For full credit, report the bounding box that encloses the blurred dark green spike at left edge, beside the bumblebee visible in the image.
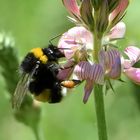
[0,35,19,95]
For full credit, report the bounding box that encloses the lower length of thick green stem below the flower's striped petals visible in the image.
[94,85,107,140]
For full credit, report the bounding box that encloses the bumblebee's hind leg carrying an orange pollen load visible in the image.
[61,79,82,88]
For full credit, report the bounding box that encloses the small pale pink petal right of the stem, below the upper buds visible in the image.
[109,22,126,40]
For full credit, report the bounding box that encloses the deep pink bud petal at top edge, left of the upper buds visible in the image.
[62,0,80,16]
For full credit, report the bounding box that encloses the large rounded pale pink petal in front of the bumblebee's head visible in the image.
[58,27,93,59]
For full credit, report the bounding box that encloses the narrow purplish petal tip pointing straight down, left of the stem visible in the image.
[83,80,94,103]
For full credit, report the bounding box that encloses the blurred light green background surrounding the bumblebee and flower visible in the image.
[0,0,140,140]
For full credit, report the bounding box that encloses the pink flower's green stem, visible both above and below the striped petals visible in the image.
[93,27,107,140]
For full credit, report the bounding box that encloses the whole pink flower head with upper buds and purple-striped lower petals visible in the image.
[58,0,140,103]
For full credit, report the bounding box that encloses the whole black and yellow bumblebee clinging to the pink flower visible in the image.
[12,44,80,108]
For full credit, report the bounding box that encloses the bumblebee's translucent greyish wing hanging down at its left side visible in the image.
[12,73,30,109]
